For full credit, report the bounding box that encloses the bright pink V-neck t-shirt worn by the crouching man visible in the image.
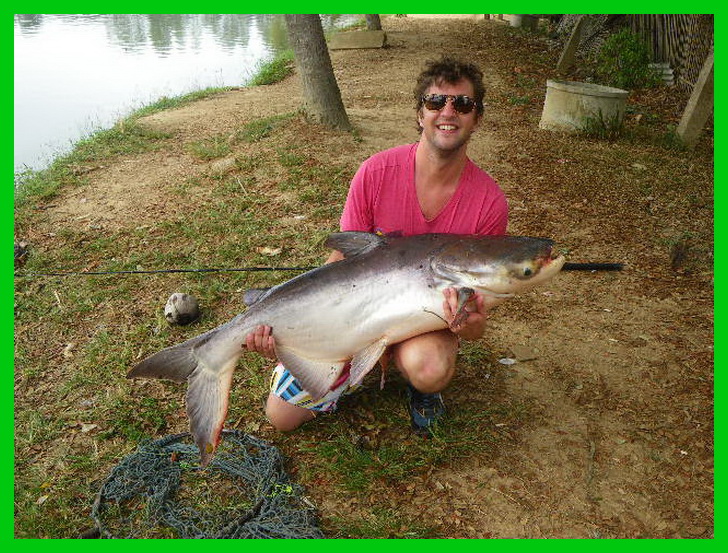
[341,142,508,236]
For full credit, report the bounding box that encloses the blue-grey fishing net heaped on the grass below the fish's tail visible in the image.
[91,430,324,538]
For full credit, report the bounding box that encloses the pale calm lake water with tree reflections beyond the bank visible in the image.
[14,14,362,171]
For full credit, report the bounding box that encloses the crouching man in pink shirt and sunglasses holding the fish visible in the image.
[246,58,508,436]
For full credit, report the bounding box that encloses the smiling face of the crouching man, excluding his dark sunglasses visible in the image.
[418,79,480,153]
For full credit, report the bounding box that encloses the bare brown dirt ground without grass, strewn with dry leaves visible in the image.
[19,18,713,538]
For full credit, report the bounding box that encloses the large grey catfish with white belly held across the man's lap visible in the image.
[128,232,564,466]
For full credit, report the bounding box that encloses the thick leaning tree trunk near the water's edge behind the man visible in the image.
[286,14,351,130]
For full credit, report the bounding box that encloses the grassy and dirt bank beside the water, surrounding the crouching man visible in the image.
[15,18,713,538]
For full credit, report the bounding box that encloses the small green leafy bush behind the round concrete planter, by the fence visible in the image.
[596,29,661,89]
